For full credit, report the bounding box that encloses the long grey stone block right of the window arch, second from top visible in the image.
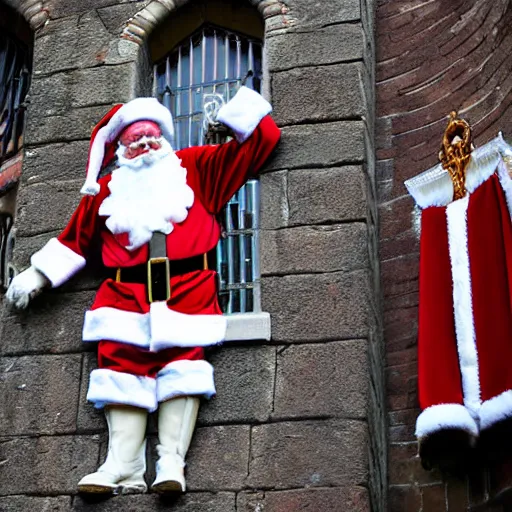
[265,23,364,71]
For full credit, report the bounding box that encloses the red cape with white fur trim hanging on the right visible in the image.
[406,136,512,450]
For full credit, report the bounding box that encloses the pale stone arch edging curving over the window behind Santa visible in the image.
[121,0,293,45]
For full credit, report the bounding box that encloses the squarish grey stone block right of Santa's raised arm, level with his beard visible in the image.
[288,165,366,225]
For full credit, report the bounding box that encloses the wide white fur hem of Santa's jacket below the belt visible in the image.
[83,302,226,352]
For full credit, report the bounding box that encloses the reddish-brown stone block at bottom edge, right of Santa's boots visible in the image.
[237,486,371,512]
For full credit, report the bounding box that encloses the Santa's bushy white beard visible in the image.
[99,140,194,251]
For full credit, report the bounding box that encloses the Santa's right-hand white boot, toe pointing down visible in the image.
[151,396,199,493]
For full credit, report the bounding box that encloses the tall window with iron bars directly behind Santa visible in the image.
[154,26,262,313]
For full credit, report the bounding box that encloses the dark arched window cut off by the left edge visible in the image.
[0,4,32,287]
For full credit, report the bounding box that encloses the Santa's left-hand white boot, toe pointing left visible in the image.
[78,406,148,494]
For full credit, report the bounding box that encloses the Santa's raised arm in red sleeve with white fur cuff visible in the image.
[186,87,280,214]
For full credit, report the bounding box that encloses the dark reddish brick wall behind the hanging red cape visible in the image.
[376,0,512,512]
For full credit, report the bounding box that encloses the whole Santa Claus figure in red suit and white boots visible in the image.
[7,87,279,493]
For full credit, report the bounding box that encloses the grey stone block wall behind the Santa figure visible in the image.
[0,0,386,512]
